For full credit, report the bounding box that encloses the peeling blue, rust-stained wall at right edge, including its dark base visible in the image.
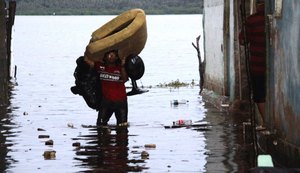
[260,0,300,164]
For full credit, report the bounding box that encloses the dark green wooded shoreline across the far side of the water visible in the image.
[12,0,203,15]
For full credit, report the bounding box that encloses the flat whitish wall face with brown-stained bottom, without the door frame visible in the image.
[203,0,225,95]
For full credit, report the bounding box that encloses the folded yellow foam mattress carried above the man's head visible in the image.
[85,9,147,61]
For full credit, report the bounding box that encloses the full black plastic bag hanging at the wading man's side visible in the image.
[71,56,102,110]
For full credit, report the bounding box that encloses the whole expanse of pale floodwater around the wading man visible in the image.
[0,15,253,173]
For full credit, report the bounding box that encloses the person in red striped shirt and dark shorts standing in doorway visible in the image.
[240,0,266,129]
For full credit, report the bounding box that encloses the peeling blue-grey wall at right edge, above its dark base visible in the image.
[267,0,300,146]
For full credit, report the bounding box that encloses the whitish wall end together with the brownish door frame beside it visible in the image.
[203,0,244,101]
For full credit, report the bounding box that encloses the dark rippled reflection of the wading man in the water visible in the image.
[74,127,146,173]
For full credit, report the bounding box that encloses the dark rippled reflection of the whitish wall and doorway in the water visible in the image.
[204,103,254,173]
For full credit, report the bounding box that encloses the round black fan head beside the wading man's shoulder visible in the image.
[125,55,145,80]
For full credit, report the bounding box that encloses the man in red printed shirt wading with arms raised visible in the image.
[84,50,128,126]
